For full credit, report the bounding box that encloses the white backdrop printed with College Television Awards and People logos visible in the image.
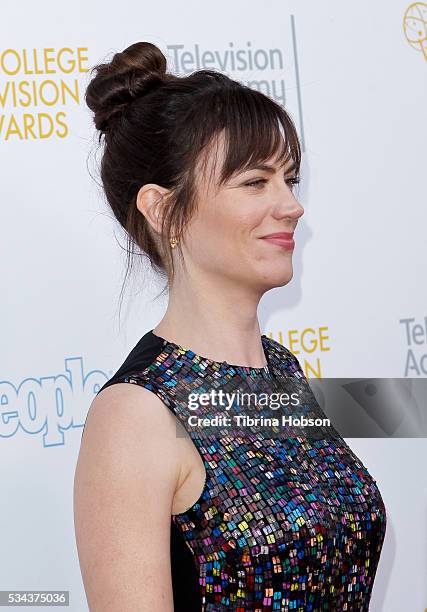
[0,0,427,612]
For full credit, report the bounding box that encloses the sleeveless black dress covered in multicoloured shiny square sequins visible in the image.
[93,330,386,612]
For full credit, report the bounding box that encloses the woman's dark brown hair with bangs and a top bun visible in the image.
[85,42,301,310]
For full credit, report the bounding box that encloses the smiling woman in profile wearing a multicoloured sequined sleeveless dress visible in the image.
[75,42,386,612]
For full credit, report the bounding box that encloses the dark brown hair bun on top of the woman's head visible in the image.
[85,42,166,132]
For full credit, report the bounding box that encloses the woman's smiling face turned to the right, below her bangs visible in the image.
[182,133,304,293]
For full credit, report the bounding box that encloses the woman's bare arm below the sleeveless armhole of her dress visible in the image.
[74,383,180,612]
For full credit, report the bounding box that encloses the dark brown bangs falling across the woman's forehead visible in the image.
[196,85,301,187]
